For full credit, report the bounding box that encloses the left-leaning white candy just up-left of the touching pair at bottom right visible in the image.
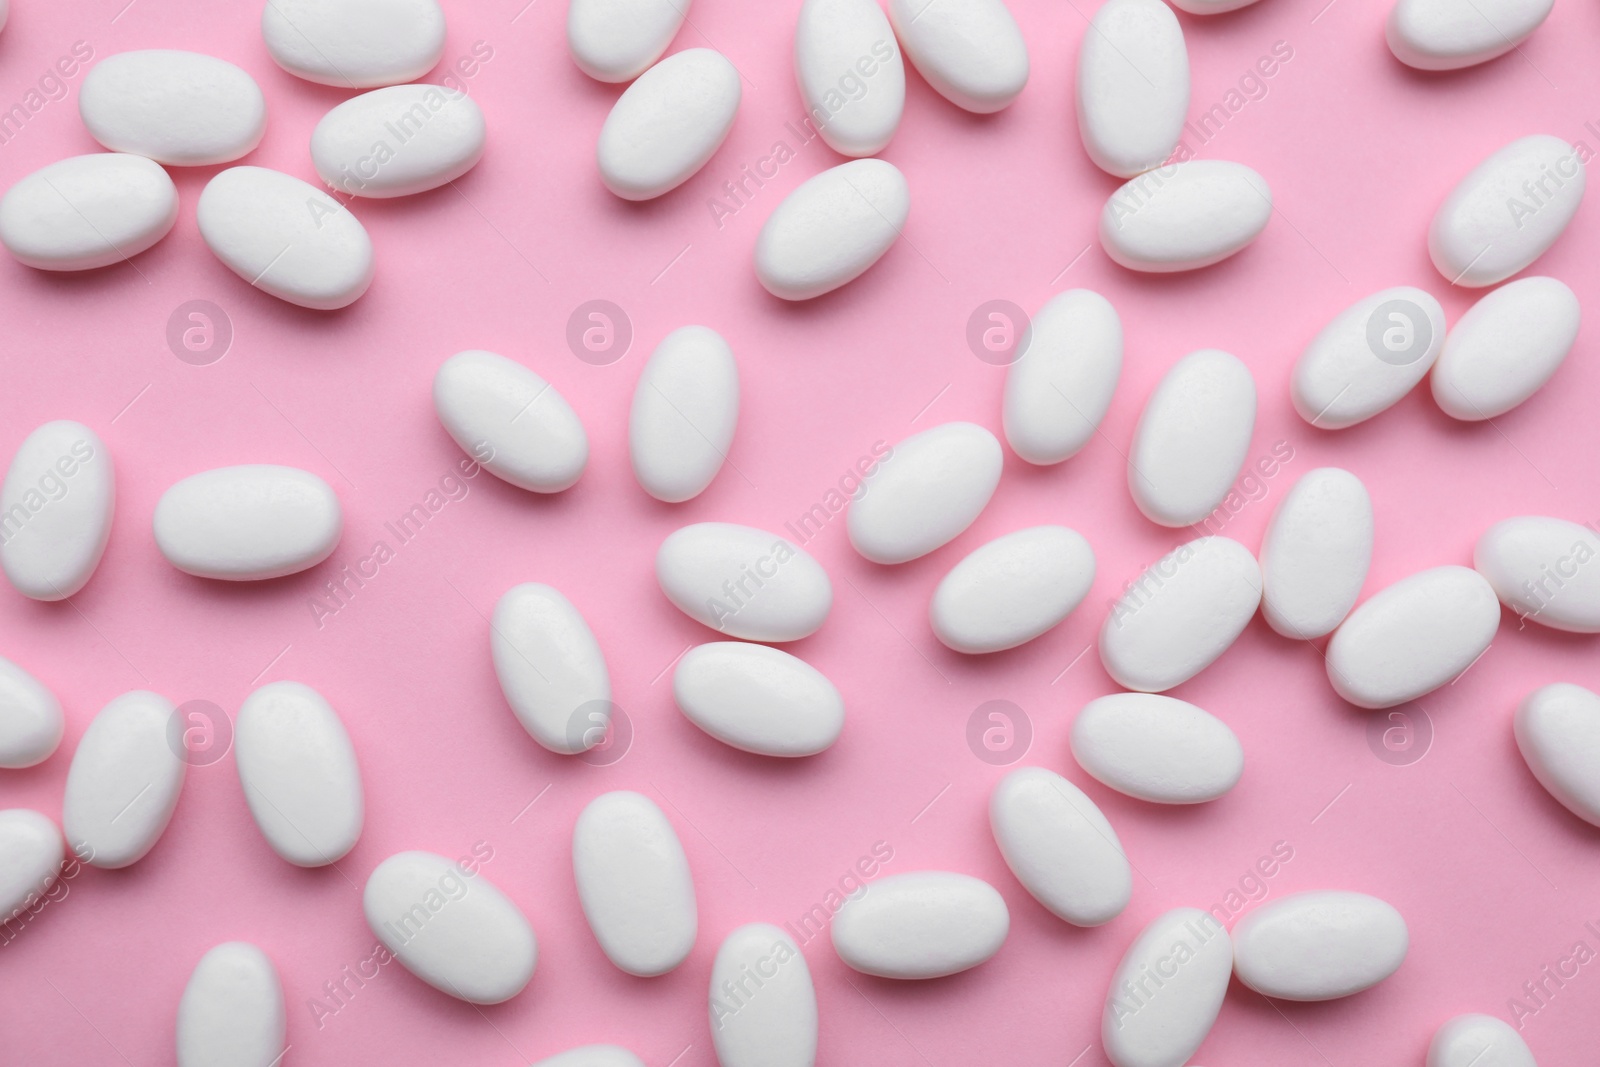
[989,766,1133,926]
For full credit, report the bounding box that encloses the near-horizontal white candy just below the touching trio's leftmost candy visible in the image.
[1072,693,1245,805]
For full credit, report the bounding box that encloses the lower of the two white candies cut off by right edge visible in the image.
[1515,681,1600,825]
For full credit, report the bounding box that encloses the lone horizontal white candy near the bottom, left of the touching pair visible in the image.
[829,870,1011,979]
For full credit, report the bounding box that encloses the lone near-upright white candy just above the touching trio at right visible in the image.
[1128,349,1256,526]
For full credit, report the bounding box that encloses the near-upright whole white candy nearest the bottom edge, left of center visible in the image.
[573,790,699,977]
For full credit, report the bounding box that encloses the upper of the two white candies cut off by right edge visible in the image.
[1472,515,1600,633]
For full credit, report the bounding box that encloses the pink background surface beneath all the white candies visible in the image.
[0,0,1600,1067]
